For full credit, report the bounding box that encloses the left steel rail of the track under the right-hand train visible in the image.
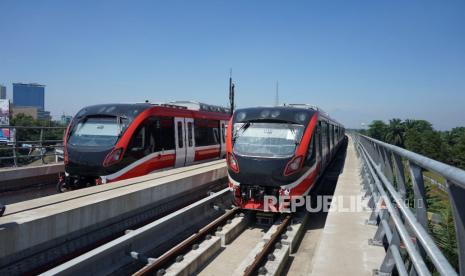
[133,207,240,276]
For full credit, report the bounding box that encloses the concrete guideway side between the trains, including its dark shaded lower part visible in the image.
[0,160,226,274]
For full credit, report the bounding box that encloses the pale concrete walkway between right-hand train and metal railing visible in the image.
[312,138,385,276]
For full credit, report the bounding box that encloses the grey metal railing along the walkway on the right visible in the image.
[352,133,465,275]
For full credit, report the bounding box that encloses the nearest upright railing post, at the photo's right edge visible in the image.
[446,180,465,276]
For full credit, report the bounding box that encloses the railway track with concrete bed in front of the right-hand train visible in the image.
[132,208,307,276]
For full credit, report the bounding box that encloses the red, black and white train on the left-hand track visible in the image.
[57,101,230,191]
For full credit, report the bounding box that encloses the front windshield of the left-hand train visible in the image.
[68,116,128,147]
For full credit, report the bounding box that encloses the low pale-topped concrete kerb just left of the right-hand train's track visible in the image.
[41,188,230,276]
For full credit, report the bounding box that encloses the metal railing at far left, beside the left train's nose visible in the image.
[0,126,66,167]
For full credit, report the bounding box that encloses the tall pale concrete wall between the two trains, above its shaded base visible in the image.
[0,160,227,267]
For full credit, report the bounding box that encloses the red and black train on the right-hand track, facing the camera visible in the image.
[226,104,345,212]
